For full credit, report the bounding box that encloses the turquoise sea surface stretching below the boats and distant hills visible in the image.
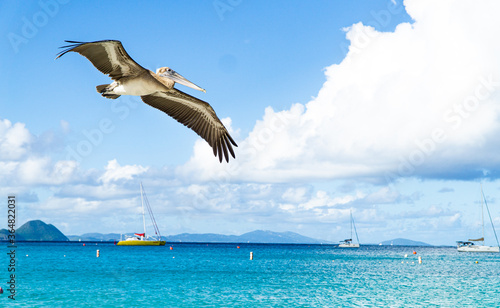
[0,243,500,307]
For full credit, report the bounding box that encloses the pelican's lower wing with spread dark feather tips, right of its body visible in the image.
[141,89,237,162]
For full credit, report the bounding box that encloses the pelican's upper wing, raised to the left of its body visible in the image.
[56,40,145,80]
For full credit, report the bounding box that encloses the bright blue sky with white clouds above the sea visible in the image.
[0,0,500,245]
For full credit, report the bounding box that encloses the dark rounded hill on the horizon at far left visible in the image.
[16,220,69,241]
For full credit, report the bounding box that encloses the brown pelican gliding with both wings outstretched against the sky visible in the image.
[56,40,237,162]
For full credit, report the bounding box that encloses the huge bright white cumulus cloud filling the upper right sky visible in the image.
[182,0,500,182]
